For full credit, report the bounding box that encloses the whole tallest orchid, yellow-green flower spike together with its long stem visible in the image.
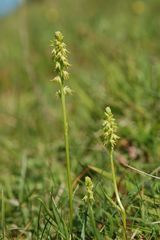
[51,31,73,229]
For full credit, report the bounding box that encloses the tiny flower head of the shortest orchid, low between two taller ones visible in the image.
[83,176,94,204]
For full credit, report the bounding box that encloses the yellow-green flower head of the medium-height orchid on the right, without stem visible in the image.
[103,107,119,149]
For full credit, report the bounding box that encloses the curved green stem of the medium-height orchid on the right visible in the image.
[110,148,127,240]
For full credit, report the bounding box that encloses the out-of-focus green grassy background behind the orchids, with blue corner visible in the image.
[0,0,160,190]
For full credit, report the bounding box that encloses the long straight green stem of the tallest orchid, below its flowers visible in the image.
[60,82,73,231]
